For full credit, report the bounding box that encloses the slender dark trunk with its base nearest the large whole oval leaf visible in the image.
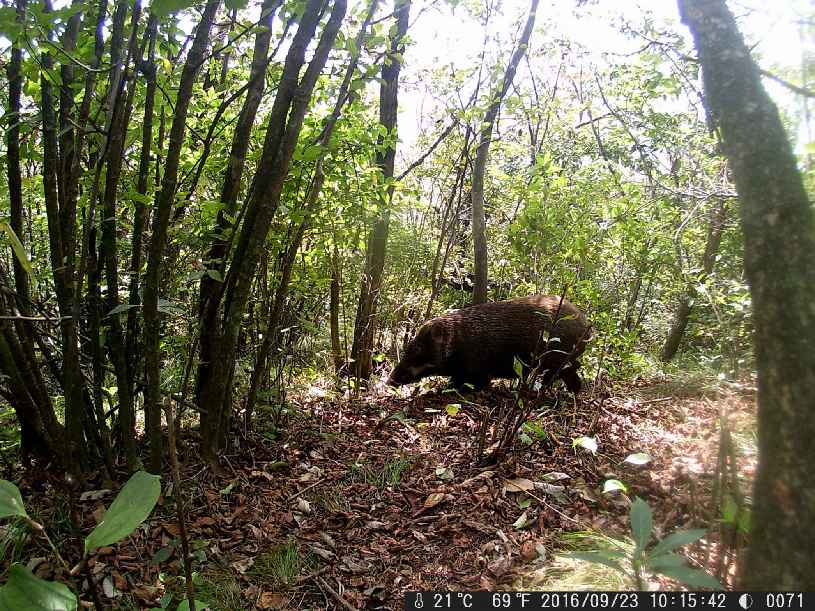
[143,0,220,473]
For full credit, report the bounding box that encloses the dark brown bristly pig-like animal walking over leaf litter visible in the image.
[388,295,592,394]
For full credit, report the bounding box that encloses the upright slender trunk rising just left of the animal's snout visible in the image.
[351,0,411,380]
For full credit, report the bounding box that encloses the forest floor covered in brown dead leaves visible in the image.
[4,370,756,611]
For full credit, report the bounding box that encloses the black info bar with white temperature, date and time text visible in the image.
[404,592,815,611]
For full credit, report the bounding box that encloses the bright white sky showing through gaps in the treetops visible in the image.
[399,0,815,152]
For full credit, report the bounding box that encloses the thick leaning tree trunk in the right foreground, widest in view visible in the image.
[679,0,815,590]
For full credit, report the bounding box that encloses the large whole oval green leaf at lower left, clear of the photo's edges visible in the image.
[85,471,161,554]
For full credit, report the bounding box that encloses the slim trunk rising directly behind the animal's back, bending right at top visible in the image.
[471,0,538,304]
